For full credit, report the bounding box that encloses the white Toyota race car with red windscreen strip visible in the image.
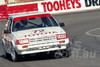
[2,12,69,61]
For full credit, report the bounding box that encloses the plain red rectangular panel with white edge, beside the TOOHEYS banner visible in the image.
[8,3,38,14]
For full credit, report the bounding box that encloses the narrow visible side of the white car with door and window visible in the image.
[4,19,12,52]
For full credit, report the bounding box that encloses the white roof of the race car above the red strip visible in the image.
[9,12,49,18]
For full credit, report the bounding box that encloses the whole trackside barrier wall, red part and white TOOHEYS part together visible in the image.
[0,0,100,19]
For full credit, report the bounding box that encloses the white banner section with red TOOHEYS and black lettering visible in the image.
[38,0,100,13]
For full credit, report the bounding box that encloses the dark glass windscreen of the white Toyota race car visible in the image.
[12,16,58,31]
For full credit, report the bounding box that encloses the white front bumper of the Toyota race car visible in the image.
[16,44,69,55]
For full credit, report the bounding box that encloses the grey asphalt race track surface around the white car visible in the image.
[0,10,100,67]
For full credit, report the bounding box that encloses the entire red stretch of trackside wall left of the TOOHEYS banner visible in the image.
[0,3,38,20]
